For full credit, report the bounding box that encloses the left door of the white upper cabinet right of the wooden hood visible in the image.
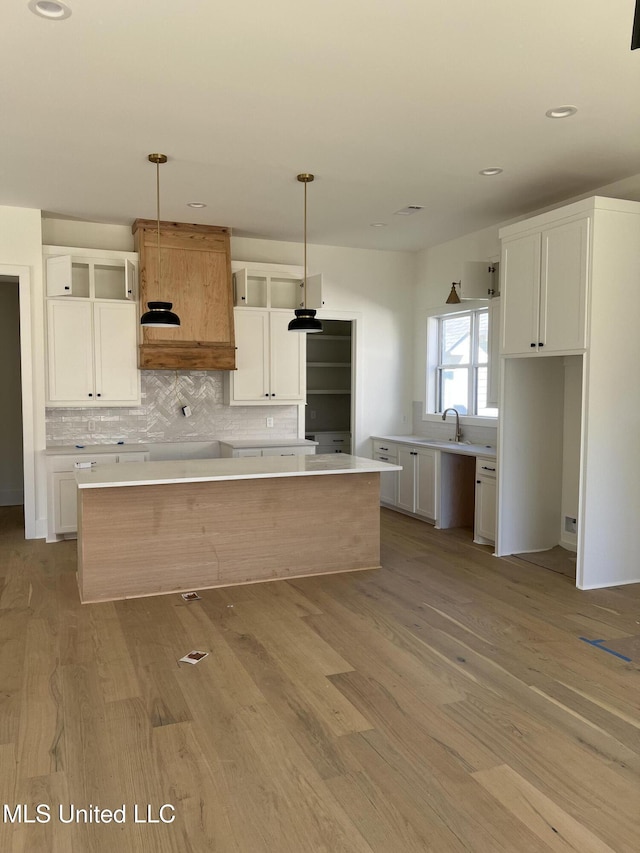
[229,308,270,403]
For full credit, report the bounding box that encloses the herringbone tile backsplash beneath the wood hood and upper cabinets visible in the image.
[47,370,297,446]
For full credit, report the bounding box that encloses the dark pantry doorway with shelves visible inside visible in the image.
[305,319,355,453]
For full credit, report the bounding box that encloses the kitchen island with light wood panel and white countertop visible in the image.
[76,453,399,603]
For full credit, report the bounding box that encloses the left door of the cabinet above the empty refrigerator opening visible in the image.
[501,234,541,355]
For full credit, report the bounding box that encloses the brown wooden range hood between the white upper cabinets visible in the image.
[132,219,236,370]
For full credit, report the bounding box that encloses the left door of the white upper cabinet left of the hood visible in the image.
[47,299,95,406]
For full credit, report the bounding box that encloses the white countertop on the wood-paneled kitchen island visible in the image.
[76,453,401,489]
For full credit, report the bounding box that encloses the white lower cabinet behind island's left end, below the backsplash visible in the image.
[47,451,149,541]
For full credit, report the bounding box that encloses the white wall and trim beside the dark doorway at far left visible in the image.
[0,207,47,537]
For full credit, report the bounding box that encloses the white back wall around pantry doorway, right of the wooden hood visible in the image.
[231,237,415,456]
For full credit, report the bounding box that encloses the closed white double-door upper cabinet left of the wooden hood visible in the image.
[47,298,140,407]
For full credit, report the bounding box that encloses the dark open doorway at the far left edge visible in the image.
[0,275,24,507]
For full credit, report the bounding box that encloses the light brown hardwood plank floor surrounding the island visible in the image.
[0,508,640,853]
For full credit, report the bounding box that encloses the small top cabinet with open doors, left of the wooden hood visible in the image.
[45,246,138,301]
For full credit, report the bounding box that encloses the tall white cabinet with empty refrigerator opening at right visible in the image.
[496,197,640,589]
